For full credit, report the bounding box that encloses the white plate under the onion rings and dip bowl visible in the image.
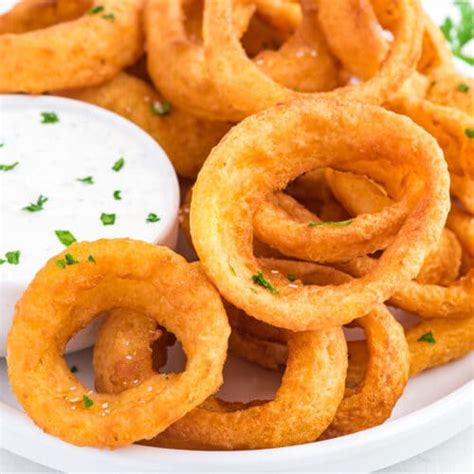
[0,0,474,472]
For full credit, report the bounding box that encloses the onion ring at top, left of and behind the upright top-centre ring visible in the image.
[145,0,338,122]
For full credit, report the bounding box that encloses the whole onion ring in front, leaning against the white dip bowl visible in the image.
[7,239,229,447]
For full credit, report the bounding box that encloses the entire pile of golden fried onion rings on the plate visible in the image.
[4,0,474,450]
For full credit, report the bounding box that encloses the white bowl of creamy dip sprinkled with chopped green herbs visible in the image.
[0,95,179,356]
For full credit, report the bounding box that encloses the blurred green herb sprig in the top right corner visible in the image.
[441,0,474,66]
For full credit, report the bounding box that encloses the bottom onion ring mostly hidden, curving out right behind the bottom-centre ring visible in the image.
[227,260,410,439]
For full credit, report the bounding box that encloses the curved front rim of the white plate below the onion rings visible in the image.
[0,379,474,472]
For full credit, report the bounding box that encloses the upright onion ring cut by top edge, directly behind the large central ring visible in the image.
[203,0,422,118]
